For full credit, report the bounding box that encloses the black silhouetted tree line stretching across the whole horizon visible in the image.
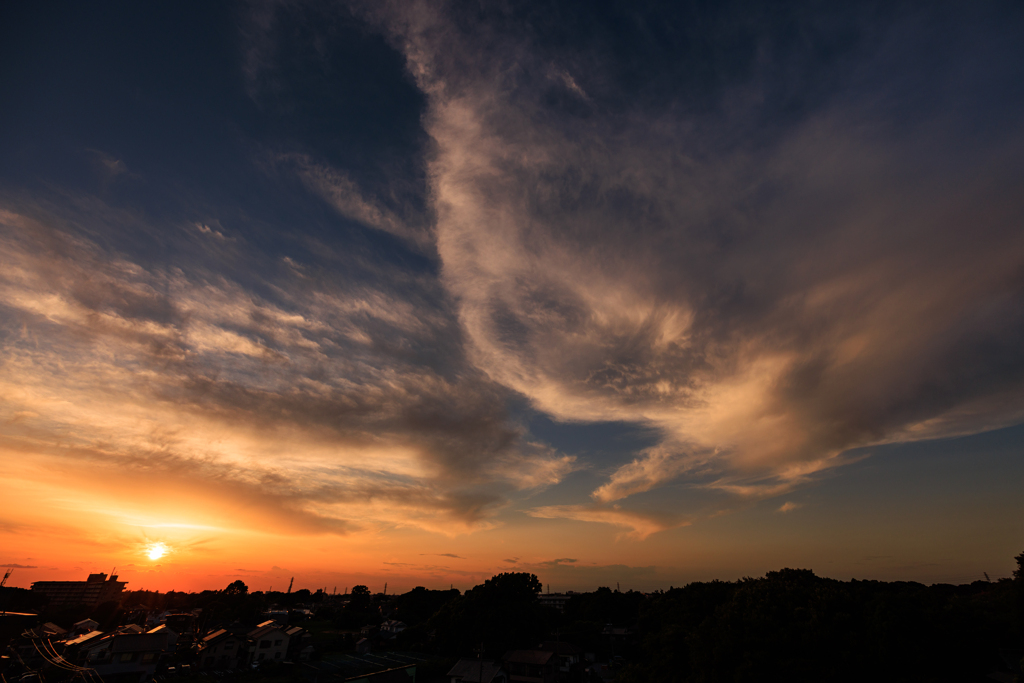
[9,553,1024,683]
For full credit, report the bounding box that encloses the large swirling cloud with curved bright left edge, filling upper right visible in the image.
[366,3,1024,520]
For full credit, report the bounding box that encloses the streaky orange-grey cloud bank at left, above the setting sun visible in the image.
[0,197,561,535]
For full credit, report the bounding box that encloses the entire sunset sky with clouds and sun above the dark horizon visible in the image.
[0,0,1024,592]
